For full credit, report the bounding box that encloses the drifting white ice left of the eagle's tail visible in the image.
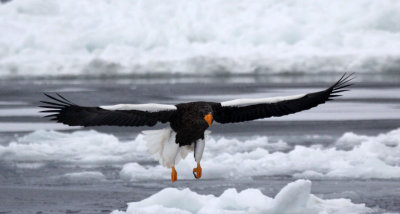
[0,130,148,166]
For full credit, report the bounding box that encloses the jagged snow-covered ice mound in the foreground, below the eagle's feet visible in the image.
[112,180,372,214]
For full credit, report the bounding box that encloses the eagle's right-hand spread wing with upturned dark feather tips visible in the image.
[213,74,353,123]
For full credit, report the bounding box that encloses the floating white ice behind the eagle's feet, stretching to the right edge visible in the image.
[120,129,400,181]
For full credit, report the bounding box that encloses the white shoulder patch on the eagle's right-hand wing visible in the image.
[221,94,306,107]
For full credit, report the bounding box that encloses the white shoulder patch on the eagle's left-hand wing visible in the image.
[100,103,177,112]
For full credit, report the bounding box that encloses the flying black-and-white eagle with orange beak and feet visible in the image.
[39,73,353,182]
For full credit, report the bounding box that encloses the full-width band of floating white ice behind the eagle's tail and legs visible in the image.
[0,129,400,179]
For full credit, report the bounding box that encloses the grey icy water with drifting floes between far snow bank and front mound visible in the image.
[0,75,400,213]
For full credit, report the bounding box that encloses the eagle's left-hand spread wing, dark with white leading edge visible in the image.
[40,94,177,126]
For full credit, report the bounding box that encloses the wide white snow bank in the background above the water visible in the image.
[0,0,400,77]
